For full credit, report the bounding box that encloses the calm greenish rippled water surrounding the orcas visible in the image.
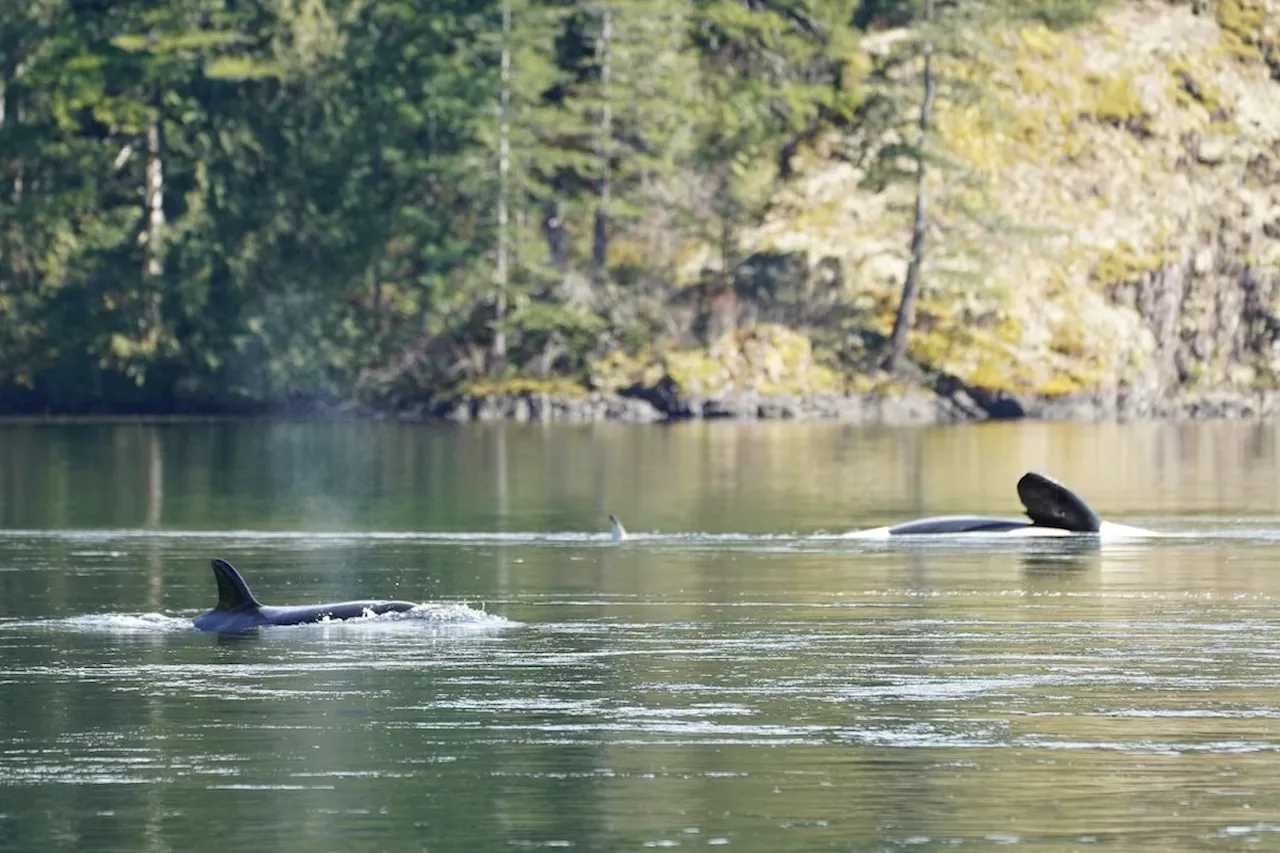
[0,423,1280,853]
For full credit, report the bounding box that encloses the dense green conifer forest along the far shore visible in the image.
[0,0,1131,412]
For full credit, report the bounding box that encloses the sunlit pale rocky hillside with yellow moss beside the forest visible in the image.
[748,0,1280,410]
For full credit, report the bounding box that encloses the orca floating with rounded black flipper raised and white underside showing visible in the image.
[844,471,1157,539]
